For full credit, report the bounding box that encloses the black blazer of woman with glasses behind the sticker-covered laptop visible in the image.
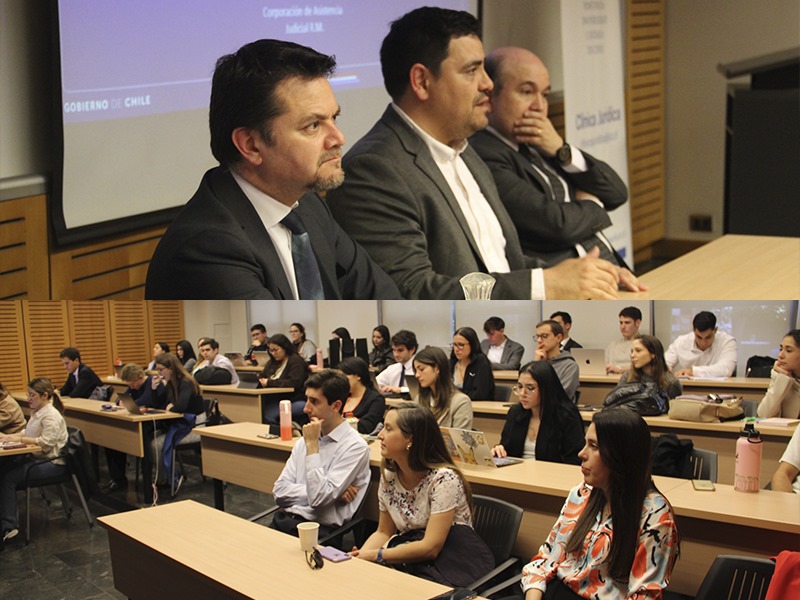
[500,402,584,465]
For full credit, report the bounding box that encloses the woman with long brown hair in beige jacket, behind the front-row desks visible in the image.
[414,346,472,429]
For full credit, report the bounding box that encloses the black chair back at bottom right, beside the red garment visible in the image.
[695,554,775,600]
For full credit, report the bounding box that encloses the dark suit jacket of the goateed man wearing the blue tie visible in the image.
[145,167,400,300]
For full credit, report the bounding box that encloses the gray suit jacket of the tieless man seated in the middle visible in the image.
[327,106,540,299]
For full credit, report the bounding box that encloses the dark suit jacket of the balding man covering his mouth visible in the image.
[469,131,628,262]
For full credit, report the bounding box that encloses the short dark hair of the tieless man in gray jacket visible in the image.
[381,6,480,102]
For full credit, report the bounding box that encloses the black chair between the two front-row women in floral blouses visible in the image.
[467,494,523,591]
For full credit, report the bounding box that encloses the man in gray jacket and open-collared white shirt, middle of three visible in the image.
[328,7,636,299]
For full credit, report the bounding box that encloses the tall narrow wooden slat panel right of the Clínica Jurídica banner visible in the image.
[625,0,666,255]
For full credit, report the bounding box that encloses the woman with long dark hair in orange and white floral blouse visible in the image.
[522,408,679,600]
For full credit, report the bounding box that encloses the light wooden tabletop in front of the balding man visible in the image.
[620,235,800,300]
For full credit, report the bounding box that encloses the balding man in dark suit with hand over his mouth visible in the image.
[470,48,628,276]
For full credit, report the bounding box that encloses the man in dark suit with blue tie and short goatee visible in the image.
[145,40,400,300]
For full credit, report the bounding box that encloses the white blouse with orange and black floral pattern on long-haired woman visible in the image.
[522,483,678,600]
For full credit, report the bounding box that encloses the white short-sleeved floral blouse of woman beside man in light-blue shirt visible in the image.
[378,467,472,533]
